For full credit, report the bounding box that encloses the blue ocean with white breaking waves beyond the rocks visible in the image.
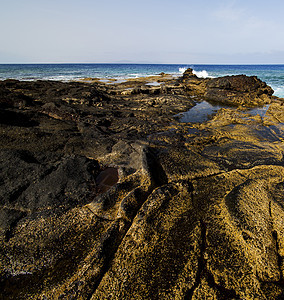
[0,64,284,98]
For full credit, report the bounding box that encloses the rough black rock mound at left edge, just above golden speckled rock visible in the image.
[0,150,100,218]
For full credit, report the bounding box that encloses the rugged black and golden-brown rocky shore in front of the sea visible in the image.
[0,69,284,299]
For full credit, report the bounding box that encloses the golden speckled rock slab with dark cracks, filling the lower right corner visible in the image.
[92,166,284,299]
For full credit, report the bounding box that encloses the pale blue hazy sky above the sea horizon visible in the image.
[0,0,284,64]
